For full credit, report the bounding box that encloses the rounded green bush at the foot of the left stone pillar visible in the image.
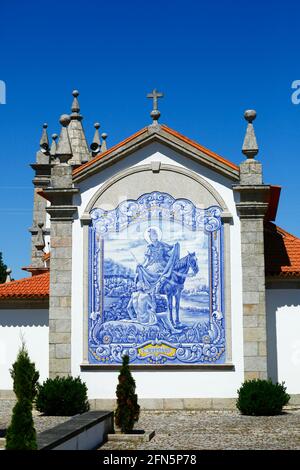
[35,377,89,416]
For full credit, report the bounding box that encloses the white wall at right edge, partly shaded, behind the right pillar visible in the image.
[266,288,300,394]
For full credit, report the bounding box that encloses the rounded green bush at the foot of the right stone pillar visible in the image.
[236,379,290,416]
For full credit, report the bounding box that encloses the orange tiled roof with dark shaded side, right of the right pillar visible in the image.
[265,222,300,278]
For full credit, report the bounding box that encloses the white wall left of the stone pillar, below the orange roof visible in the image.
[0,309,49,390]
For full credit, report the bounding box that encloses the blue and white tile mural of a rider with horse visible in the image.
[89,191,225,366]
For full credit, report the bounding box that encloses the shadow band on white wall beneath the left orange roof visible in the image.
[0,309,49,328]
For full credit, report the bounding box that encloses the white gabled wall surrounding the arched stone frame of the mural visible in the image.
[72,144,244,398]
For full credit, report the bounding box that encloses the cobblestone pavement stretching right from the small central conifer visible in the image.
[99,409,300,450]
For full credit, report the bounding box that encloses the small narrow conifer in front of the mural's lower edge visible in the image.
[115,355,140,433]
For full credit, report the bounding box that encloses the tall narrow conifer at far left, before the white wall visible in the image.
[6,343,39,450]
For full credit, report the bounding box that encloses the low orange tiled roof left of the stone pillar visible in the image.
[0,272,50,299]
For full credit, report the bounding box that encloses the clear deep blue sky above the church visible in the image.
[0,0,300,278]
